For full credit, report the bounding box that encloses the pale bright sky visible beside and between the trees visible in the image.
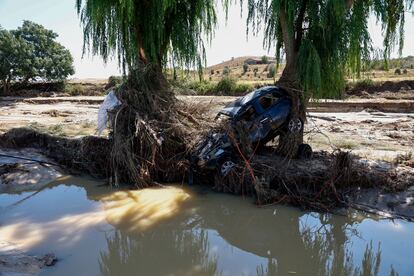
[0,0,414,78]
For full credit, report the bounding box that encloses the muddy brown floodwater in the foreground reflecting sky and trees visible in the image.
[0,177,414,275]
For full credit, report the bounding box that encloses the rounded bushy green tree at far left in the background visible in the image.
[0,21,74,92]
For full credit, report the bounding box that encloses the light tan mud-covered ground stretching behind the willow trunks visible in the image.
[0,96,414,161]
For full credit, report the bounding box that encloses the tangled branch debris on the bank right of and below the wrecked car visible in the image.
[215,151,414,211]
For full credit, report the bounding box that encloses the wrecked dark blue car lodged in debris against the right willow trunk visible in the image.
[191,86,312,179]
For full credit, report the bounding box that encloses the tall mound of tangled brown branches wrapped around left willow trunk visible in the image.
[105,66,215,188]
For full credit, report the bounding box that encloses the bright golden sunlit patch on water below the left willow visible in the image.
[101,187,190,231]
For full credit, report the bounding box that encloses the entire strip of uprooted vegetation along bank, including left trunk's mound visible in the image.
[0,67,414,210]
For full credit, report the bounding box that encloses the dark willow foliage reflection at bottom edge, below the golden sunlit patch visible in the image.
[99,229,217,275]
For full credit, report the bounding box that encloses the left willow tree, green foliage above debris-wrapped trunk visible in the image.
[76,0,216,187]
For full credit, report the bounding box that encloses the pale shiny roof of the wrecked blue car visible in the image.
[219,86,287,117]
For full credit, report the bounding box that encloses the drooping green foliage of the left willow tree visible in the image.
[76,0,216,69]
